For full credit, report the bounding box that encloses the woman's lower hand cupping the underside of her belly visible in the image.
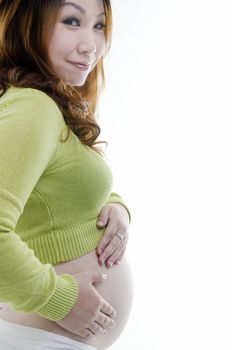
[56,271,116,339]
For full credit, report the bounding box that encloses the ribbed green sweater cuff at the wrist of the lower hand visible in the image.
[35,274,78,321]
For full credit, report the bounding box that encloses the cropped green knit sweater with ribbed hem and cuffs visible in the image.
[0,86,130,321]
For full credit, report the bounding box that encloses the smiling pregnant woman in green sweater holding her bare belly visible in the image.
[0,0,133,350]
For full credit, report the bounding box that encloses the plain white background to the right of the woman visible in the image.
[99,0,232,350]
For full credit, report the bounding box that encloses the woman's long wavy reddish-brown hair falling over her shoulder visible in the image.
[0,0,112,153]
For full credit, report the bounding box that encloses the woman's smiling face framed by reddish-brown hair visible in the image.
[48,0,106,86]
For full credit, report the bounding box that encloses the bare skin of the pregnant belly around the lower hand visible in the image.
[0,250,133,350]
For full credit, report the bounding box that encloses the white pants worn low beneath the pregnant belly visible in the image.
[0,319,96,350]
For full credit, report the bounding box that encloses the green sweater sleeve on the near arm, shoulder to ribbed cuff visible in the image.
[0,89,78,321]
